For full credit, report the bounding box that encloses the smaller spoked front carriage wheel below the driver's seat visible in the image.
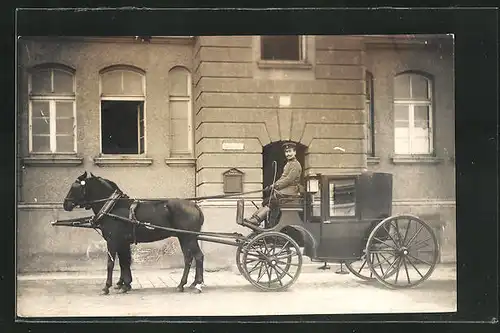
[241,231,302,291]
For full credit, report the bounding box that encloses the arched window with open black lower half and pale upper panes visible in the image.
[100,66,146,155]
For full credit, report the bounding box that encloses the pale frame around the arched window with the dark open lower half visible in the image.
[99,65,148,158]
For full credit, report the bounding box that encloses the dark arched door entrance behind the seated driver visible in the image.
[262,141,307,197]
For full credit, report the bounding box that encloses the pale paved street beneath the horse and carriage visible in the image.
[17,264,457,317]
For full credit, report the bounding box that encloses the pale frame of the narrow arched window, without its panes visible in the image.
[168,66,194,158]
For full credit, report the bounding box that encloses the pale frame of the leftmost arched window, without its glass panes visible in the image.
[28,64,78,156]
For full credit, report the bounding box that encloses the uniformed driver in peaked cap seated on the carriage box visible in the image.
[244,142,303,225]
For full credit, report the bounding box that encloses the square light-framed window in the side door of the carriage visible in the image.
[329,179,356,217]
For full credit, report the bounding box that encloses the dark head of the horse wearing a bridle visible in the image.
[63,171,118,212]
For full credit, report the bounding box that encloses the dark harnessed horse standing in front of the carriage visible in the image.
[63,171,204,295]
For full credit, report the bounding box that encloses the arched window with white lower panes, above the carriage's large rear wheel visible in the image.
[394,73,433,155]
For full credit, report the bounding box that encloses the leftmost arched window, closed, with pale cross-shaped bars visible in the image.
[28,66,76,154]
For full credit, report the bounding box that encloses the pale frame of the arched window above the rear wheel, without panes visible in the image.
[393,71,435,156]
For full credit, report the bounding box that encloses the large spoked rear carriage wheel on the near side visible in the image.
[366,215,439,288]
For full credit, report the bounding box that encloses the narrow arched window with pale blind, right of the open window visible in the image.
[168,67,193,157]
